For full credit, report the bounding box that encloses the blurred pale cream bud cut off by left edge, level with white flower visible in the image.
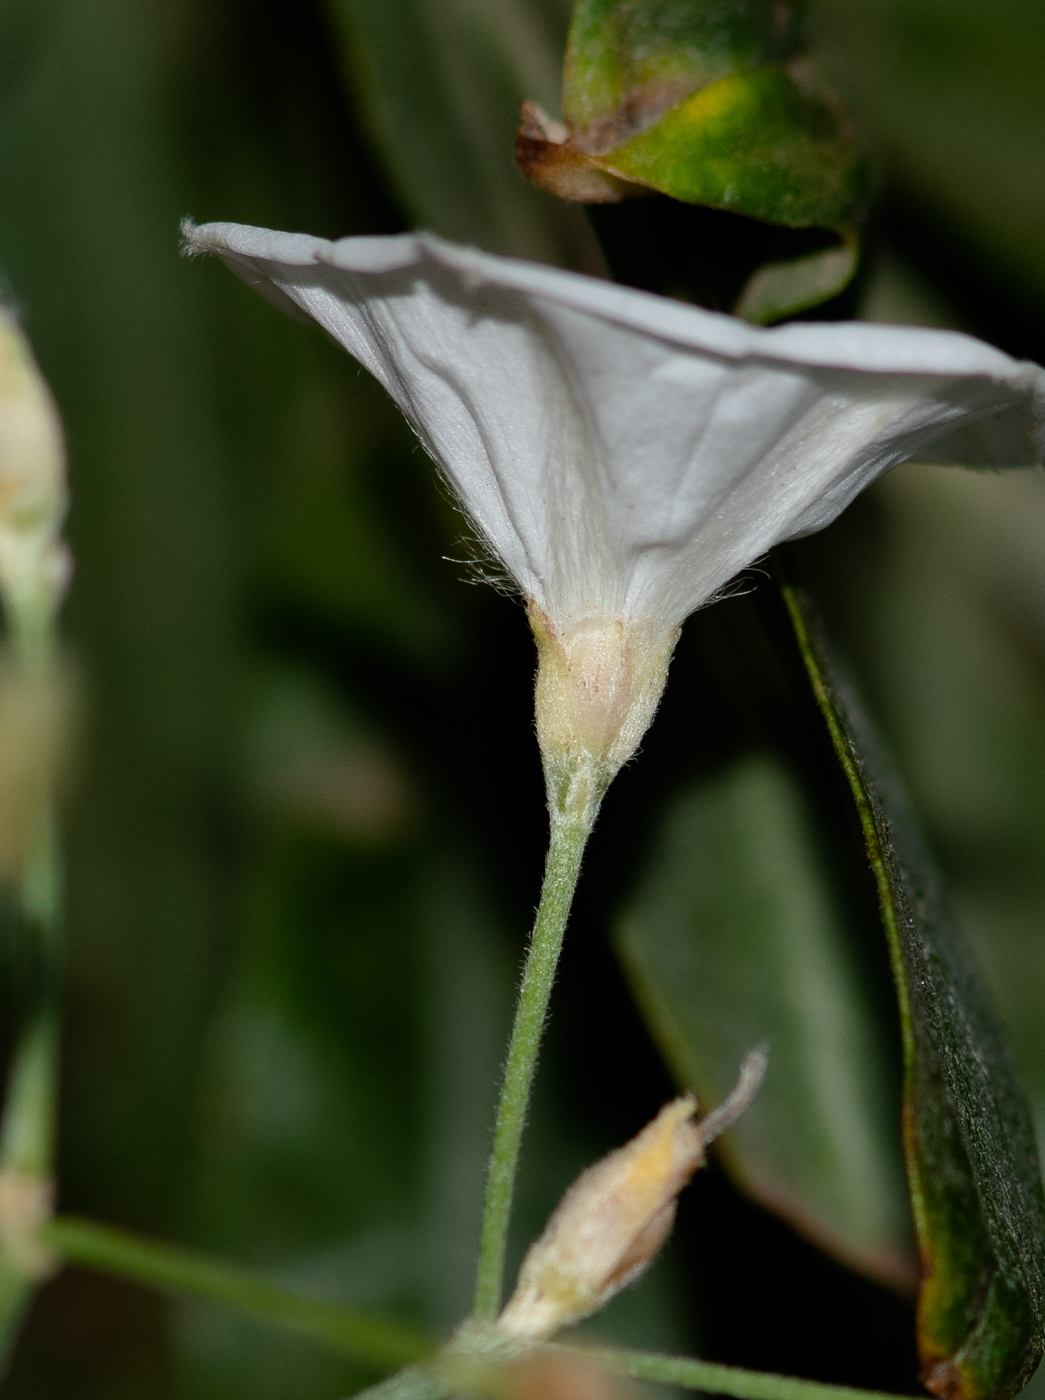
[0,308,70,634]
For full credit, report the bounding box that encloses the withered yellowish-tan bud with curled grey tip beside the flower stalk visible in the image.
[497,1050,766,1341]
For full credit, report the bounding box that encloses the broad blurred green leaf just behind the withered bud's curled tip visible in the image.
[618,755,916,1288]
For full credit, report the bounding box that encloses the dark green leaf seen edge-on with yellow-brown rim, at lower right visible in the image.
[784,585,1045,1400]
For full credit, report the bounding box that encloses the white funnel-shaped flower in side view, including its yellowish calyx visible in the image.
[185,224,1045,812]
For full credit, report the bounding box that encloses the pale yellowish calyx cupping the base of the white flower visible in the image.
[530,603,678,806]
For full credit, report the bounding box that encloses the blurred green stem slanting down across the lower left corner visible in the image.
[39,1215,437,1371]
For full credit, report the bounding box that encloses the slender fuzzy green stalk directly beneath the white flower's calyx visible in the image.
[475,804,595,1320]
